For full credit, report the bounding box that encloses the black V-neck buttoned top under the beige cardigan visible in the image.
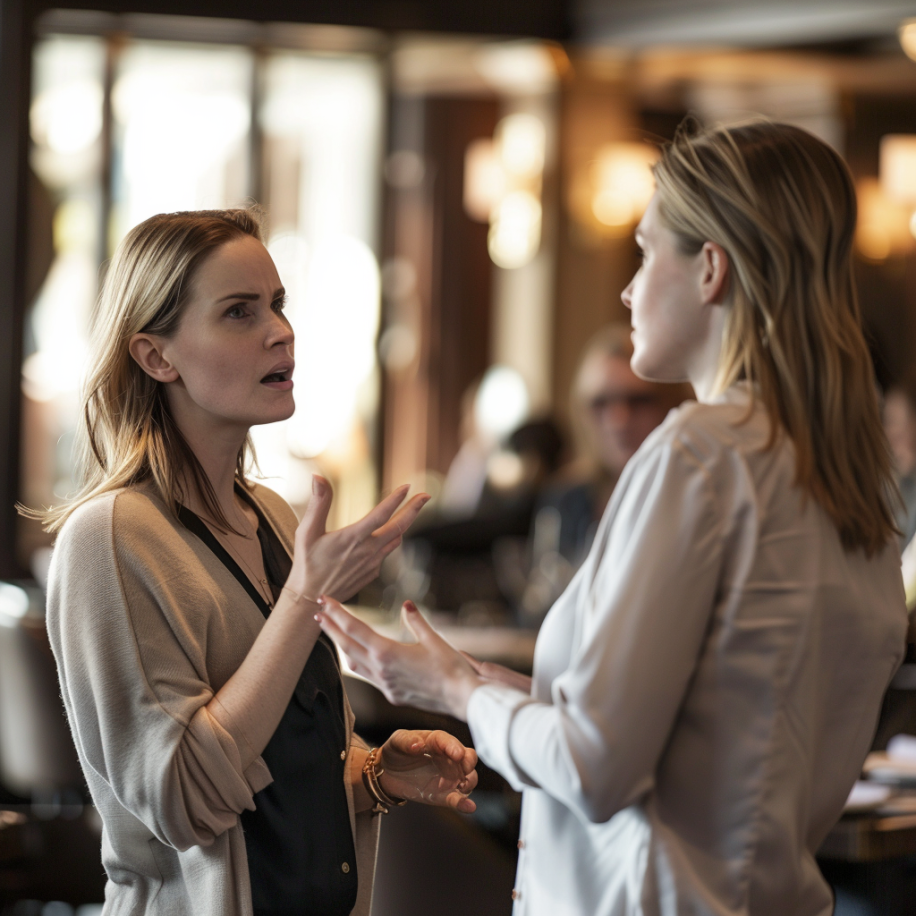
[179,487,357,916]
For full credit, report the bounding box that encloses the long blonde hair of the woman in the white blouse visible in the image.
[655,121,896,555]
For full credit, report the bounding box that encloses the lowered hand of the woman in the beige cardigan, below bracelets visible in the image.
[379,728,477,814]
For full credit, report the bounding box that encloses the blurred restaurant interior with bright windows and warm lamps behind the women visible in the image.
[0,0,916,916]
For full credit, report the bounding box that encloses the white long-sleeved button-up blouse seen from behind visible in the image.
[468,387,907,916]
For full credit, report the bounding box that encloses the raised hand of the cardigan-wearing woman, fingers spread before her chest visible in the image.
[286,474,429,600]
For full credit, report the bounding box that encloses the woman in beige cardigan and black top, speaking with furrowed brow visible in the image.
[36,210,476,916]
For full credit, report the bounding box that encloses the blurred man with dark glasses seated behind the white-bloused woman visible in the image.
[539,323,693,567]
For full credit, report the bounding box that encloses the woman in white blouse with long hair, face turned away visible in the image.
[320,122,906,916]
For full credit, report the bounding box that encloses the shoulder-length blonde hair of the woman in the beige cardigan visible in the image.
[28,208,262,531]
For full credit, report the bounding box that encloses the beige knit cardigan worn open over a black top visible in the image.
[47,486,378,916]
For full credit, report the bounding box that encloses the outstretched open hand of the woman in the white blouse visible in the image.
[316,597,484,719]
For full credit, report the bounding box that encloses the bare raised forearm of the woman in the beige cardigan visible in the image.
[208,589,321,769]
